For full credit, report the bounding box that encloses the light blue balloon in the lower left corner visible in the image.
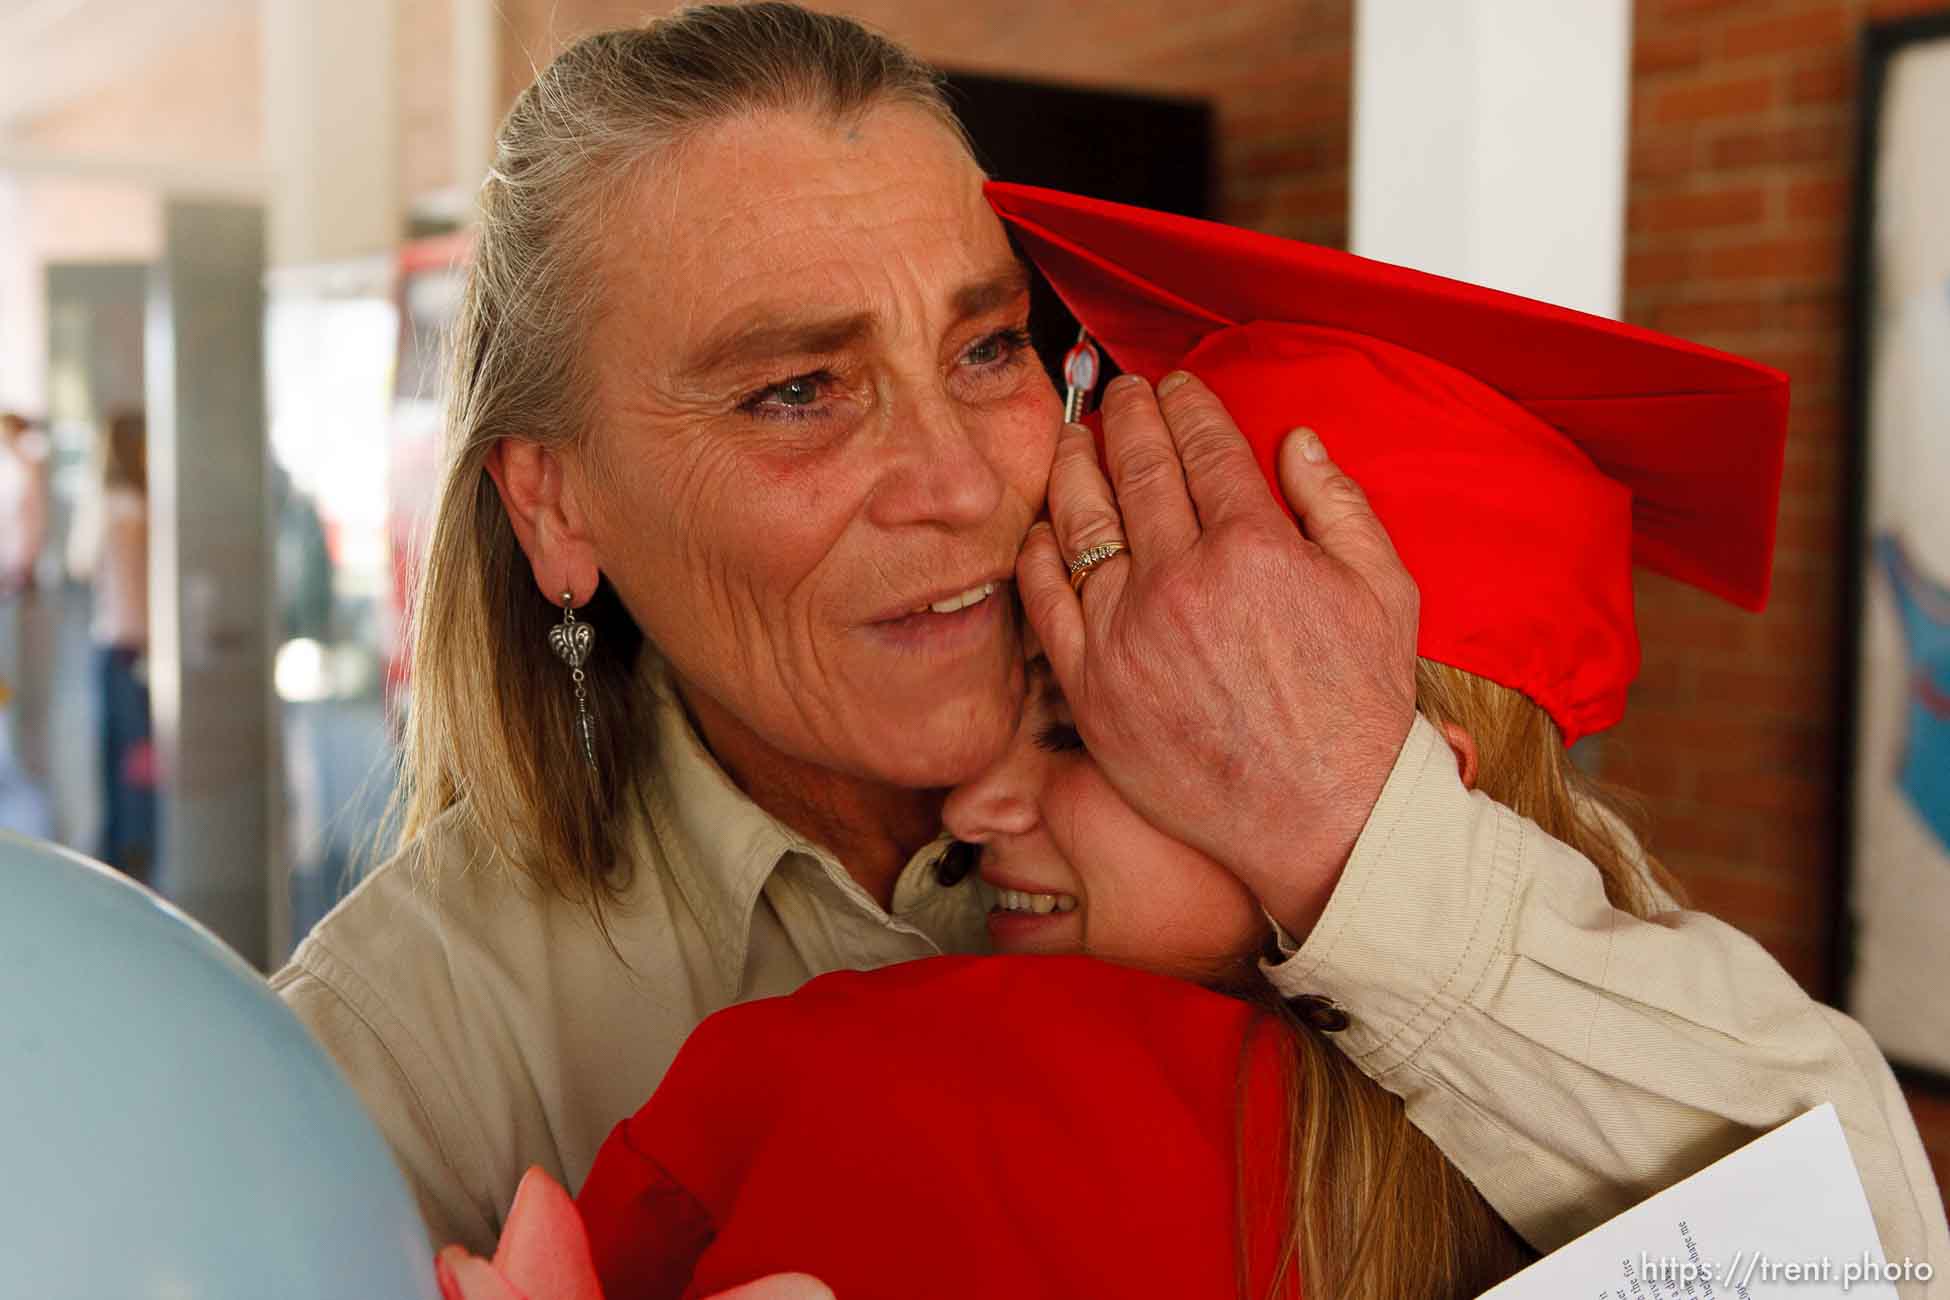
[0,832,439,1300]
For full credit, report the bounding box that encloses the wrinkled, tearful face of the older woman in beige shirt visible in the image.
[569,107,1061,787]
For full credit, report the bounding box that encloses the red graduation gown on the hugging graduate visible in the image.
[577,957,1299,1300]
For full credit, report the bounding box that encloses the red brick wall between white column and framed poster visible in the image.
[1607,0,1950,1185]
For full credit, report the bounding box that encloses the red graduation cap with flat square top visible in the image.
[989,183,1788,745]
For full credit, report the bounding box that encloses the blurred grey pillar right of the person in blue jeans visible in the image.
[144,203,279,965]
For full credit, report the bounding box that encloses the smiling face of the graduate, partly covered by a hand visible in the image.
[944,661,1268,982]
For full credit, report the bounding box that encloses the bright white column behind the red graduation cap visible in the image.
[1351,0,1632,318]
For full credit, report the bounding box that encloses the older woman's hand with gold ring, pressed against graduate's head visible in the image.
[1016,372,1418,937]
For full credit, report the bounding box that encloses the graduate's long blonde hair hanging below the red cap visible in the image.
[1240,659,1677,1300]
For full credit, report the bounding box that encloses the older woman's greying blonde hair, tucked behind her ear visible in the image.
[396,4,967,904]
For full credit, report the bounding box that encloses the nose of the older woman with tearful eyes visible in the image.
[868,385,1004,528]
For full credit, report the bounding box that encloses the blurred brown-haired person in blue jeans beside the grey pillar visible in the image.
[68,411,156,883]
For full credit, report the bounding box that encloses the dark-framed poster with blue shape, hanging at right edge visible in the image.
[1847,10,1950,1086]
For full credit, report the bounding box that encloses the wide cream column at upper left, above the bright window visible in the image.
[263,0,402,267]
